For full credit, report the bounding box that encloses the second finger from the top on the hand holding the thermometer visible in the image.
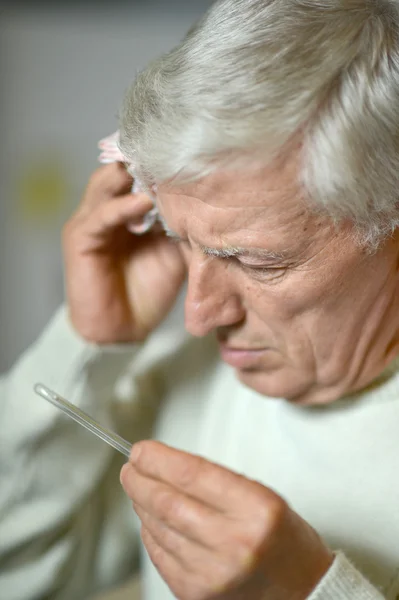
[121,464,219,549]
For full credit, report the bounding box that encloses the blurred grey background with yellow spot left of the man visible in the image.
[0,0,216,372]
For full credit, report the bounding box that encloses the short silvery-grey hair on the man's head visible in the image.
[120,0,399,245]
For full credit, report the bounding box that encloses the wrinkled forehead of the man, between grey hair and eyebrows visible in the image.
[158,167,332,258]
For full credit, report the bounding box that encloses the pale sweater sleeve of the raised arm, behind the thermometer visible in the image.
[0,308,149,600]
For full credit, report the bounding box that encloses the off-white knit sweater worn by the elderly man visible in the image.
[0,309,399,600]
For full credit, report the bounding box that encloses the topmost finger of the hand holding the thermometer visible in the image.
[130,441,272,513]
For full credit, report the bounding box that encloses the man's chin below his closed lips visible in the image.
[236,369,342,406]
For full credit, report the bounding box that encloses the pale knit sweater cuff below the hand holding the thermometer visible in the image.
[308,552,384,600]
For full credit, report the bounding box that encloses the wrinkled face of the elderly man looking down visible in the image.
[159,152,399,404]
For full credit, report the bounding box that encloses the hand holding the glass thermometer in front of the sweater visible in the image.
[121,442,333,600]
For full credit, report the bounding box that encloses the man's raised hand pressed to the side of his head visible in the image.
[63,163,186,344]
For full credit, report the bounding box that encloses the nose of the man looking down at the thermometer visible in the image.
[185,253,245,337]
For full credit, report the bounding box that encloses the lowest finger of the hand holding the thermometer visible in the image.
[141,527,209,600]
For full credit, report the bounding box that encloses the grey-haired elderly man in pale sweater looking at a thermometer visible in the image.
[0,0,399,600]
